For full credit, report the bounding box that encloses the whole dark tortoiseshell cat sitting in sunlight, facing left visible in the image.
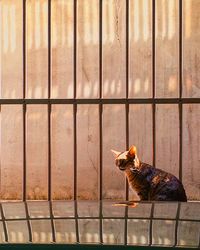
[112,146,187,201]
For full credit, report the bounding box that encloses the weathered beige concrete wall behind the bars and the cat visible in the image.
[0,0,200,200]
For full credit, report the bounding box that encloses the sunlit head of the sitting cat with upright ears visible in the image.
[111,146,139,171]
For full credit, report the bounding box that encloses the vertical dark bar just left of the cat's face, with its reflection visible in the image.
[99,0,103,244]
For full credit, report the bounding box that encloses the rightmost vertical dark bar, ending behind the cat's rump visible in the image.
[179,0,183,181]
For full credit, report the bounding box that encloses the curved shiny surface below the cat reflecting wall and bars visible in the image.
[0,201,200,248]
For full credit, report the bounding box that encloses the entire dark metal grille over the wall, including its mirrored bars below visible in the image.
[0,0,200,247]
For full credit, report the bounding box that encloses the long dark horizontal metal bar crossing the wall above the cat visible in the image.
[0,98,200,105]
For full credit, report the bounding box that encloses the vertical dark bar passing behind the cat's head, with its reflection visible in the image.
[124,0,129,245]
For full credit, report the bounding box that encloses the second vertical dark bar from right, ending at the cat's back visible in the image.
[152,0,156,166]
